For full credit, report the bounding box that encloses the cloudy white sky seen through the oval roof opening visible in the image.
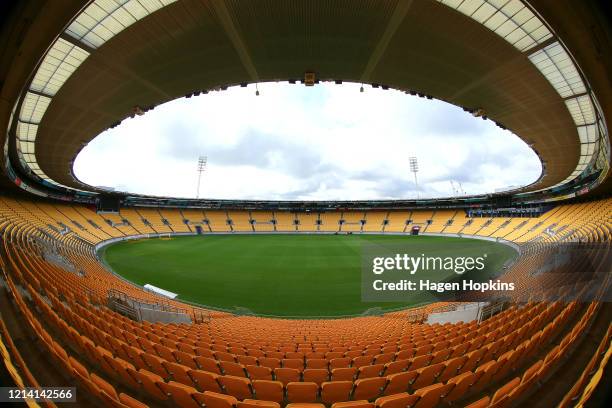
[74,83,541,200]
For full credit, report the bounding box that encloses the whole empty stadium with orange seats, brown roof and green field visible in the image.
[0,0,612,408]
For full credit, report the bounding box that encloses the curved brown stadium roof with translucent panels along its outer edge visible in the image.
[0,0,612,201]
